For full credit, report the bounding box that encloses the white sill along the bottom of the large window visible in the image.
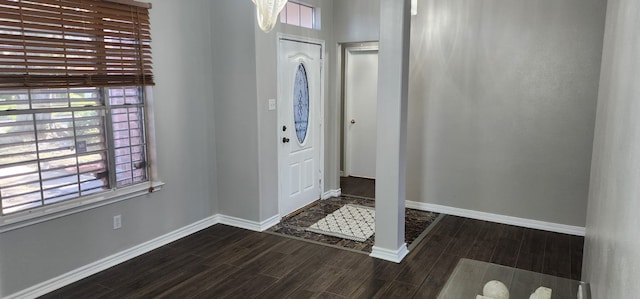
[0,181,164,233]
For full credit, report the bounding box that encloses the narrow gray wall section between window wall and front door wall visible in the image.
[208,0,260,221]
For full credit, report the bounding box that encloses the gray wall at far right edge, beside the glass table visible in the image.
[582,0,640,298]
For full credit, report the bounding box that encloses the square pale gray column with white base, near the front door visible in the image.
[371,0,411,263]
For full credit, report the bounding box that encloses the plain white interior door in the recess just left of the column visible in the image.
[344,48,378,178]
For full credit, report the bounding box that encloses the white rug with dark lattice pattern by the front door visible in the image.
[307,204,376,242]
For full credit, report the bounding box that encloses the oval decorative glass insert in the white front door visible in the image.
[293,63,309,144]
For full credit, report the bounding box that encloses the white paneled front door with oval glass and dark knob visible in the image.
[277,38,323,216]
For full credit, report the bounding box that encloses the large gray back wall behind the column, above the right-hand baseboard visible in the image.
[334,0,606,226]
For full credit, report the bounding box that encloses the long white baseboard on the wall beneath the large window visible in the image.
[6,215,219,299]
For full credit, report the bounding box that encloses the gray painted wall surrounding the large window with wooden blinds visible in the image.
[0,0,218,297]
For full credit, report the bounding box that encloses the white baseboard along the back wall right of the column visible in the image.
[405,200,585,236]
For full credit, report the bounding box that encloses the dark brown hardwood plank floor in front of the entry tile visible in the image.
[43,216,584,298]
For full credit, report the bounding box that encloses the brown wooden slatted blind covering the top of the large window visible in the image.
[0,0,154,89]
